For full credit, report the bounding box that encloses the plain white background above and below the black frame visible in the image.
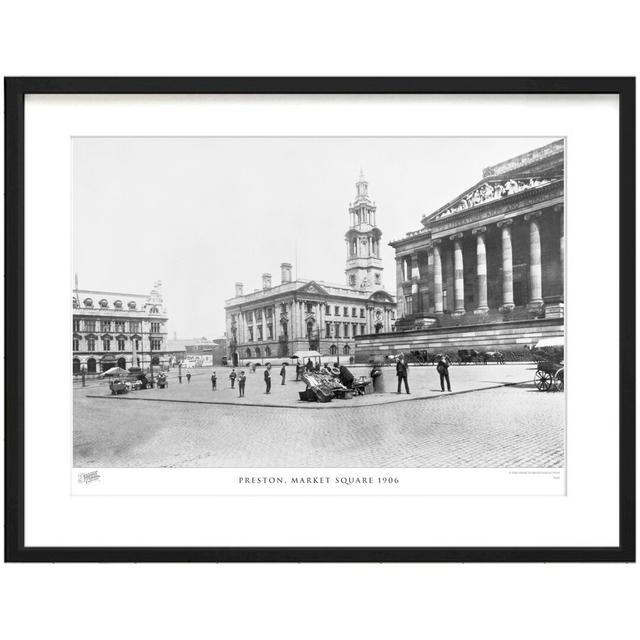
[0,0,640,640]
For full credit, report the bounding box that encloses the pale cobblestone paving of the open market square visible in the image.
[74,364,564,467]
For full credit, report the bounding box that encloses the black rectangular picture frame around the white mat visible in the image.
[4,77,636,562]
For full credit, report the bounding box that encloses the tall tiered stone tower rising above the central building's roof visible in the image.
[345,170,383,290]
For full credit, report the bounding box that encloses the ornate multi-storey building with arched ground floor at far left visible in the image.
[72,282,168,374]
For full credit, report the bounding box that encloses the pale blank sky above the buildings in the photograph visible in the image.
[72,137,554,338]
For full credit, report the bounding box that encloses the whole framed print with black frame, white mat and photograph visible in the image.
[5,78,635,562]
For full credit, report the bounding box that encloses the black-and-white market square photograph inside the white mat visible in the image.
[69,135,571,476]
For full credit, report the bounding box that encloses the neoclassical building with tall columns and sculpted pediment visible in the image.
[358,140,564,355]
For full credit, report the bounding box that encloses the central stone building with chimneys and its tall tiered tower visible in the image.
[225,173,396,365]
